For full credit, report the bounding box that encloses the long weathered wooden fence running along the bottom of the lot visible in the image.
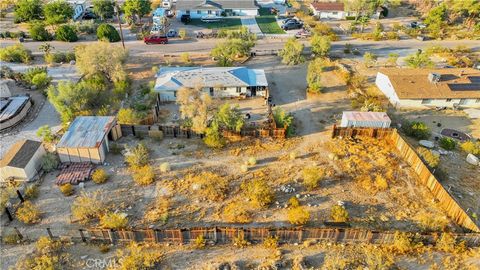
[48,227,474,246]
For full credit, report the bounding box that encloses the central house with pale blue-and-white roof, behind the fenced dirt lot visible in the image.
[154,67,268,101]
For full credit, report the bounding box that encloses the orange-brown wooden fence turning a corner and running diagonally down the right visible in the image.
[332,126,480,232]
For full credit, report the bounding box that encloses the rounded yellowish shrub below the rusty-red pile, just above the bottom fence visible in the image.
[72,192,105,224]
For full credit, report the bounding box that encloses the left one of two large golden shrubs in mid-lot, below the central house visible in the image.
[188,172,229,201]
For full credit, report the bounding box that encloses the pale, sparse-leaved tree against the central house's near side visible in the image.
[177,87,212,133]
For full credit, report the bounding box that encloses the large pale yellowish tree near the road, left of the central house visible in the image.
[75,42,127,83]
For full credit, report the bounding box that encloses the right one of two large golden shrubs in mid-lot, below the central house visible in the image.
[241,178,275,208]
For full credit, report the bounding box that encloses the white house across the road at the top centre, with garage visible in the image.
[176,0,258,19]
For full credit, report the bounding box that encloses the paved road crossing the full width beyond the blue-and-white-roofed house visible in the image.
[0,39,480,57]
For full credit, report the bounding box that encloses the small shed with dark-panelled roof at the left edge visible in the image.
[0,140,45,182]
